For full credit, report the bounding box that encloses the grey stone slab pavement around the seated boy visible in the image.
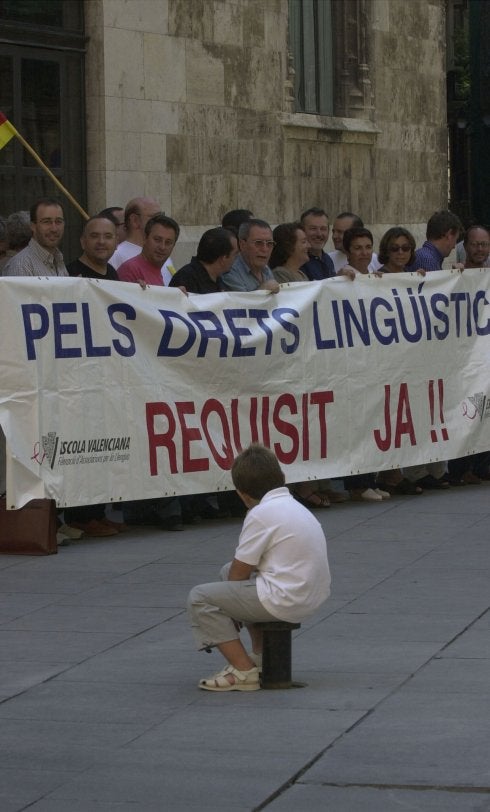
[0,485,490,812]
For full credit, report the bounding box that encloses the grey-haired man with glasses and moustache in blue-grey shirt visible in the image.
[221,218,279,293]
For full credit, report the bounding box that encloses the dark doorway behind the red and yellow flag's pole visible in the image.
[0,0,86,260]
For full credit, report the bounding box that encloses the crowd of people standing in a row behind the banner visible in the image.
[0,197,490,537]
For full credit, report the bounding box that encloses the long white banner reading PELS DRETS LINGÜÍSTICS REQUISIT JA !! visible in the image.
[0,270,490,507]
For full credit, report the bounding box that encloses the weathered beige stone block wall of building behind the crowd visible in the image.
[85,0,447,258]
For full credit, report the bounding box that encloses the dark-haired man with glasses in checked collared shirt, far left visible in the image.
[3,197,68,276]
